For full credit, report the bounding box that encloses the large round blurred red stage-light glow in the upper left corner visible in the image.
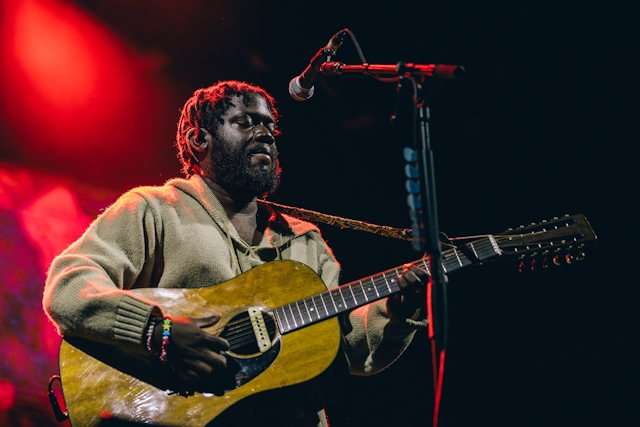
[0,0,164,176]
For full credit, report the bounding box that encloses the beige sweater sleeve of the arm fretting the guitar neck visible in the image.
[308,235,426,375]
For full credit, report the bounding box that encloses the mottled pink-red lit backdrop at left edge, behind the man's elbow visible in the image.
[0,163,118,414]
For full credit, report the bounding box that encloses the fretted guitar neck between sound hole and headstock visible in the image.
[273,236,501,334]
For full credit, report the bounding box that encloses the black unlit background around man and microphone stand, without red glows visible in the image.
[0,0,638,426]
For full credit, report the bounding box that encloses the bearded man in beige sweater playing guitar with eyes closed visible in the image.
[43,81,428,425]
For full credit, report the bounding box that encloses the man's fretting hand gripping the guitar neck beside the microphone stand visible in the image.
[387,264,430,323]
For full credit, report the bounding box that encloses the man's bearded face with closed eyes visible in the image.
[205,94,280,196]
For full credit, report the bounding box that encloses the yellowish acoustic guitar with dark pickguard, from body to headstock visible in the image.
[60,215,596,427]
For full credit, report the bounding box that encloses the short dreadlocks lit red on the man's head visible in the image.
[174,80,279,178]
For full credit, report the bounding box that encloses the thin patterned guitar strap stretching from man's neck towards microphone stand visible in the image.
[258,199,412,241]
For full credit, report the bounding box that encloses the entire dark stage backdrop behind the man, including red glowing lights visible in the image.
[0,0,638,427]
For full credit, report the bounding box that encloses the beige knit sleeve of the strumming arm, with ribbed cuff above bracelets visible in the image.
[43,193,162,348]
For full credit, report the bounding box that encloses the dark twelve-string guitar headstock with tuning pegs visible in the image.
[494,214,597,271]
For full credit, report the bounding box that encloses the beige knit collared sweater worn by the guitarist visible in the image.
[43,176,424,425]
